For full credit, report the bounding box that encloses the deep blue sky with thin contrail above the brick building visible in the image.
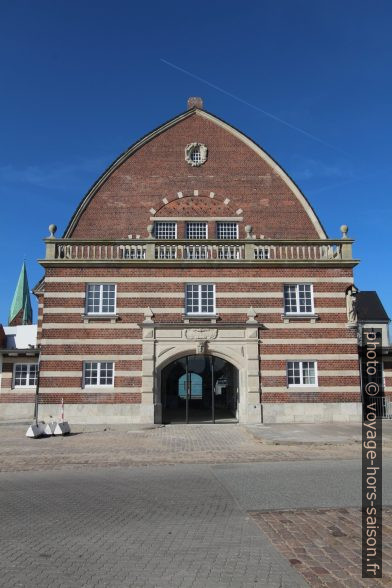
[0,0,392,324]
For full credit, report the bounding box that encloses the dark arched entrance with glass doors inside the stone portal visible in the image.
[161,355,239,423]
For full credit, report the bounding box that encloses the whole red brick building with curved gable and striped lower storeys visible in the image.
[3,99,361,423]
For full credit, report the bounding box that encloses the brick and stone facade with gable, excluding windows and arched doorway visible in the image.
[1,101,368,422]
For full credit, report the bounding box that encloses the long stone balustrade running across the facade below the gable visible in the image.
[41,237,358,267]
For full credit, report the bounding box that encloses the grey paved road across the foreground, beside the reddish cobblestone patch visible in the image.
[0,461,392,588]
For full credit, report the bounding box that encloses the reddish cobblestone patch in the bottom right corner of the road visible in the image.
[252,507,392,588]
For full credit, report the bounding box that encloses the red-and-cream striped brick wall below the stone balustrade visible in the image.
[28,267,359,403]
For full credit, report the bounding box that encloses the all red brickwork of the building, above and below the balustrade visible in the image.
[14,114,359,414]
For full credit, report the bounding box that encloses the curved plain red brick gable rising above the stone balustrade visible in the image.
[64,108,327,239]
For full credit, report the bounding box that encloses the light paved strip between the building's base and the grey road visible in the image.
[0,424,392,471]
